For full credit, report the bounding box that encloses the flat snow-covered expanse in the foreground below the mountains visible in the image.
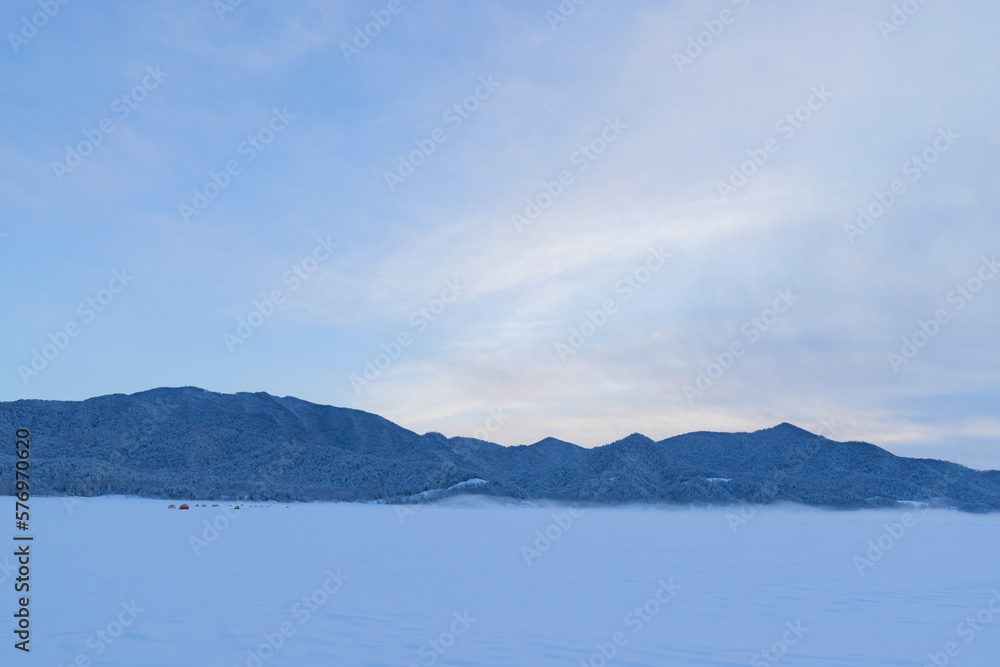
[7,498,1000,667]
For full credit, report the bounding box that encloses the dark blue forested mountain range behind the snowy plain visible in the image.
[0,387,1000,512]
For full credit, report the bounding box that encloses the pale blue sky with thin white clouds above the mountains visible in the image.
[0,0,1000,469]
